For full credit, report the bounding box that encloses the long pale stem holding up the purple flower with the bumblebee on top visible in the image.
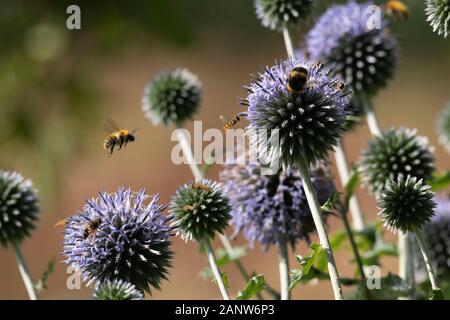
[298,157,344,300]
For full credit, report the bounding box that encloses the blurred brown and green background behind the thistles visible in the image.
[0,0,450,299]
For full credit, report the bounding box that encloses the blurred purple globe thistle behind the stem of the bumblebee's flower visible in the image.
[221,164,334,249]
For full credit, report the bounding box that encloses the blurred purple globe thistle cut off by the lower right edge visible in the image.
[417,195,450,275]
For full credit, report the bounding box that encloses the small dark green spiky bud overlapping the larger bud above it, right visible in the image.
[378,176,435,233]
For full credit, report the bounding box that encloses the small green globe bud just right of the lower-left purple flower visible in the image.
[170,179,231,242]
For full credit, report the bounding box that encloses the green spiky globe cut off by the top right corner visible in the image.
[425,0,450,38]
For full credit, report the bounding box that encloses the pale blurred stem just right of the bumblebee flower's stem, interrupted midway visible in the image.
[334,141,364,231]
